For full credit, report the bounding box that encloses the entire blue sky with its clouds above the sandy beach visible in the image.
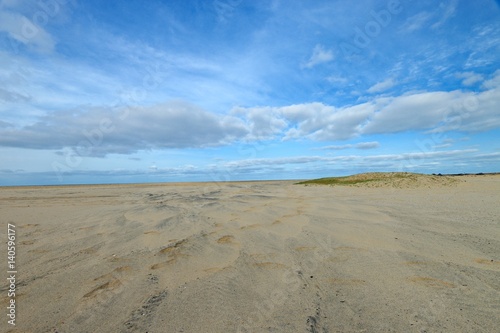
[0,0,500,185]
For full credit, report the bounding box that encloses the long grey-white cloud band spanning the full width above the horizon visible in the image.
[0,80,500,156]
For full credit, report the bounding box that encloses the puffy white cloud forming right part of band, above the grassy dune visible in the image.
[276,81,500,141]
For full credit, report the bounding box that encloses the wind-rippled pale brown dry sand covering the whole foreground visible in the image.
[0,176,500,333]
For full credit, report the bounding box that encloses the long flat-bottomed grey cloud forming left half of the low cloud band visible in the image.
[0,102,247,156]
